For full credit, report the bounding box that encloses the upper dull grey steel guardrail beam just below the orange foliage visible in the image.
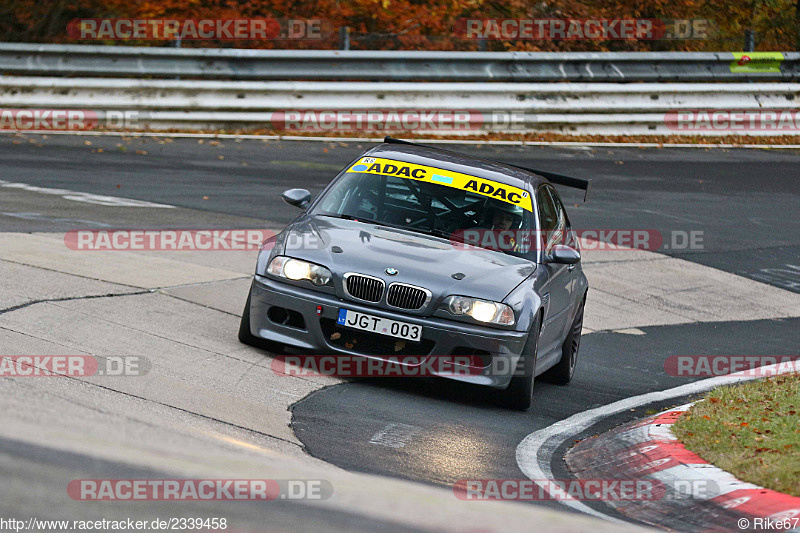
[0,43,800,83]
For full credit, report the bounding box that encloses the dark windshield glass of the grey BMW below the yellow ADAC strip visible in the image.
[311,168,535,256]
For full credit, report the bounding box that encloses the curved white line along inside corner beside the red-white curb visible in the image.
[517,363,796,523]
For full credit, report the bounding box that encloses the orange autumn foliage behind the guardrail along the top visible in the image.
[0,0,800,51]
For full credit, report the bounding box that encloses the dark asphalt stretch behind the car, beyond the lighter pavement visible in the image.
[0,135,800,292]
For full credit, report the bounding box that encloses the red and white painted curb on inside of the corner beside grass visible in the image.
[566,402,800,532]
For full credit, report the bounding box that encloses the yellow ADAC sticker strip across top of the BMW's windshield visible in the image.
[347,157,533,211]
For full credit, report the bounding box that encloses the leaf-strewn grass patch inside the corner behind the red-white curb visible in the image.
[672,374,800,496]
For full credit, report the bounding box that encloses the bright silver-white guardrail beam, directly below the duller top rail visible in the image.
[0,76,800,114]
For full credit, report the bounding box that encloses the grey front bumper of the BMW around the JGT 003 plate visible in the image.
[250,275,528,388]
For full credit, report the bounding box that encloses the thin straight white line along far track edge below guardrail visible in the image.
[0,130,800,150]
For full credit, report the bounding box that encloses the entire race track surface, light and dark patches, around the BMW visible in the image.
[0,135,800,531]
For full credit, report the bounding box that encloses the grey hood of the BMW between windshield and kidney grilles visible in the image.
[282,216,536,301]
